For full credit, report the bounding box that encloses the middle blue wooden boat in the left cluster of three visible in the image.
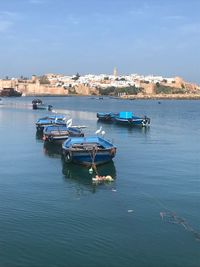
[43,125,84,144]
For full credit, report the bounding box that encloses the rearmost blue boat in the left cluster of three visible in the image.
[36,115,66,132]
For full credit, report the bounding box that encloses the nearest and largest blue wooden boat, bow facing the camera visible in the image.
[62,136,116,166]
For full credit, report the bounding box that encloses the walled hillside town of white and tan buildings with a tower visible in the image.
[0,68,200,98]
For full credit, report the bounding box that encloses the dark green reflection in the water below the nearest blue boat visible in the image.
[62,160,116,193]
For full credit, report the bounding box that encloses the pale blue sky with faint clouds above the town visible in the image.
[0,0,200,84]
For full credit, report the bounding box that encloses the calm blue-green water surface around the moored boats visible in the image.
[0,97,200,267]
